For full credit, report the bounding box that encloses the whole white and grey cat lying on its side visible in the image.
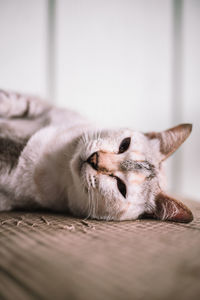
[0,90,193,222]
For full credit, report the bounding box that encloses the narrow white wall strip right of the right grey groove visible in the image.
[180,0,200,199]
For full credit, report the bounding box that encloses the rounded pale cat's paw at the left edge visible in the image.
[0,90,28,118]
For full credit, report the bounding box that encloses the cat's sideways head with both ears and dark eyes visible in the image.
[71,124,193,222]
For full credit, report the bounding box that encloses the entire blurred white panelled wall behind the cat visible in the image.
[0,0,200,200]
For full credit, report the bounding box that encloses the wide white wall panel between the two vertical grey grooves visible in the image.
[57,0,171,130]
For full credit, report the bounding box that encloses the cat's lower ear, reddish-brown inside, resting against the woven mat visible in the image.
[144,192,193,223]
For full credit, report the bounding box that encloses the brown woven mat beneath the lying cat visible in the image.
[0,202,200,300]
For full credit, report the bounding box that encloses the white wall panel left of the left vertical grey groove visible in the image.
[0,0,47,95]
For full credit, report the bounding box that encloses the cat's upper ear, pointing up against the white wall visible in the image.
[145,124,192,160]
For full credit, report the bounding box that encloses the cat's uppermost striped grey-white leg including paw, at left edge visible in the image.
[0,90,51,119]
